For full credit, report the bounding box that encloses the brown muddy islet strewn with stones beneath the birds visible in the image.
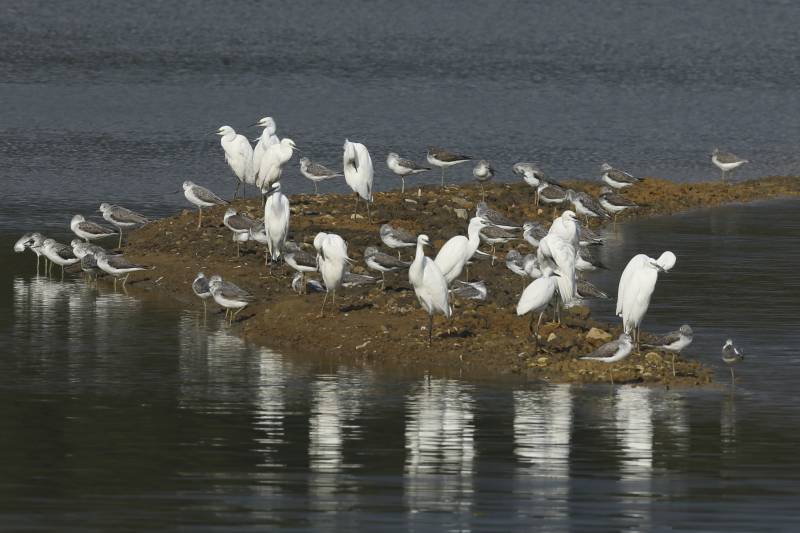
[125,177,800,386]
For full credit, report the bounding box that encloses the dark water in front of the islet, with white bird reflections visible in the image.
[0,201,800,531]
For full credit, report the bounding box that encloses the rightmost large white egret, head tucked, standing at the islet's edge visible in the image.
[616,252,676,349]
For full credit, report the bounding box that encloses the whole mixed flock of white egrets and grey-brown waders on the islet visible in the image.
[14,117,747,378]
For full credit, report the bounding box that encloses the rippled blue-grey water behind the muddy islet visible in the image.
[0,0,800,229]
